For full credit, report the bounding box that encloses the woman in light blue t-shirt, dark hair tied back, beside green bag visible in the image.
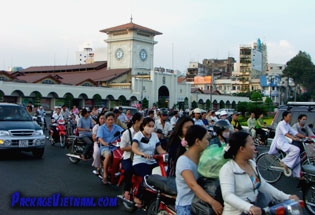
[175,125,222,215]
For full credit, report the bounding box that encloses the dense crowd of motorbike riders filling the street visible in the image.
[27,103,305,215]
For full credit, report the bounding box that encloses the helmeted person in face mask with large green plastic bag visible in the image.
[191,120,230,215]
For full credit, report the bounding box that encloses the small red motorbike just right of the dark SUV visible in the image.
[49,120,66,148]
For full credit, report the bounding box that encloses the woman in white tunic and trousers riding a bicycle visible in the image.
[268,111,305,178]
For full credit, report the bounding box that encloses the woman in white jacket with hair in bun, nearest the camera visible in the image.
[219,131,299,215]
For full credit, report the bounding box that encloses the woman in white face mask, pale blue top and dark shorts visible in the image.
[131,117,166,207]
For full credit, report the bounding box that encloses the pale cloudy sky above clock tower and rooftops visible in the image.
[0,0,315,72]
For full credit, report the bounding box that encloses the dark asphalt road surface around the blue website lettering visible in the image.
[0,140,312,215]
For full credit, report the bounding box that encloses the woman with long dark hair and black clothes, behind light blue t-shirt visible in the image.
[166,116,194,176]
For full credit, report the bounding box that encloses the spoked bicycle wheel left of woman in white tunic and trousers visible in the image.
[256,152,282,184]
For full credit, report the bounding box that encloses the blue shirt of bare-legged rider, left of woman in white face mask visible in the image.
[96,124,124,153]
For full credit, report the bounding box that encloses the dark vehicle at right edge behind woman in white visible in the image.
[269,102,315,137]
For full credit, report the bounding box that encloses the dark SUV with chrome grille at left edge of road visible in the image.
[0,103,46,158]
